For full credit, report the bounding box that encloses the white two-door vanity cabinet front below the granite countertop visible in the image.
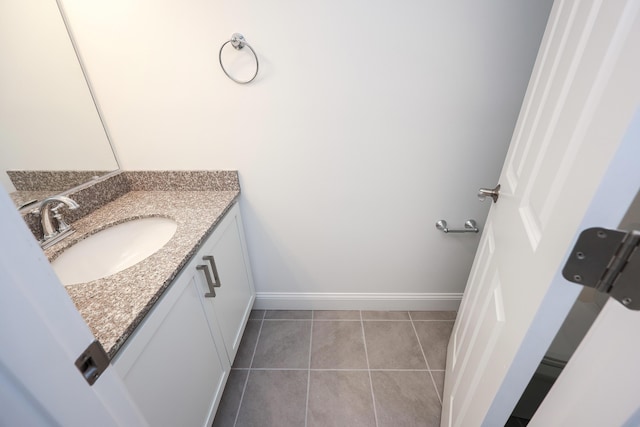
[112,204,255,427]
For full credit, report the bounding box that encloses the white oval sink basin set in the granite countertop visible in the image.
[51,217,178,286]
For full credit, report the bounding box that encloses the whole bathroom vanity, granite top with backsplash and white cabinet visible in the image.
[38,172,255,426]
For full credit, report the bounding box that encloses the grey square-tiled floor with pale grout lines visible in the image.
[213,310,455,427]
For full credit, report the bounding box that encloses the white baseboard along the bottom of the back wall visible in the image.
[254,292,462,311]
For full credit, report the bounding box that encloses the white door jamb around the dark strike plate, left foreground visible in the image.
[0,189,146,426]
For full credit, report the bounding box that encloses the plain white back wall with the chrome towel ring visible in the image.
[62,0,552,304]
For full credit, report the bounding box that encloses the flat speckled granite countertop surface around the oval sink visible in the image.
[45,190,240,359]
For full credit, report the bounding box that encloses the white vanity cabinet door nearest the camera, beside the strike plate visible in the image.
[114,274,229,427]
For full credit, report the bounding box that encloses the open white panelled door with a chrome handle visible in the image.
[442,0,640,426]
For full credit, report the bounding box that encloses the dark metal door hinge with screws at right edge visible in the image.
[562,228,640,310]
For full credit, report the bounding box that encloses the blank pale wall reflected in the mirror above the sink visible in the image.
[0,0,118,191]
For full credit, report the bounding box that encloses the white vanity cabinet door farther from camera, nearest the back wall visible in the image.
[200,205,255,363]
